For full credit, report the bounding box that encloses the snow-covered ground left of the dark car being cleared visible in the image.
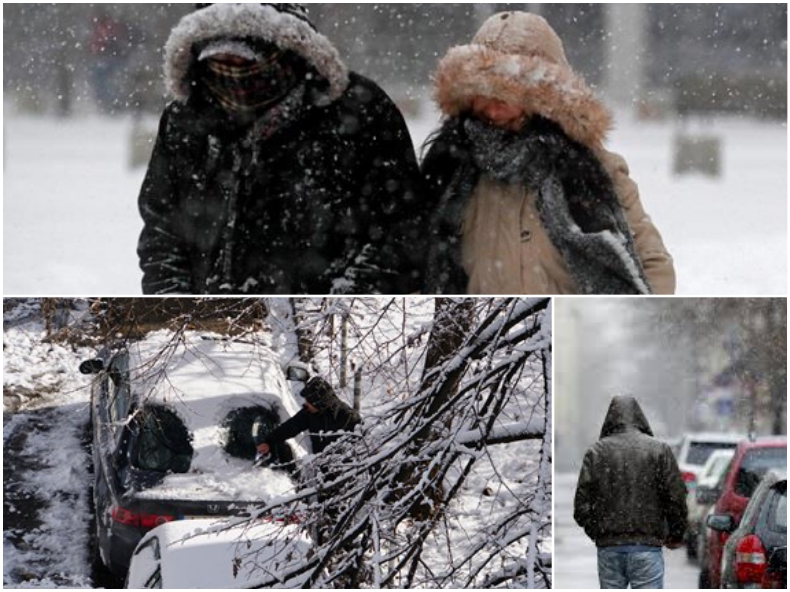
[3,306,91,588]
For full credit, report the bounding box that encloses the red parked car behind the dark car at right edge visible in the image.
[699,437,787,588]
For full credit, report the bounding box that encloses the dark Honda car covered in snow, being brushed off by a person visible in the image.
[80,331,306,578]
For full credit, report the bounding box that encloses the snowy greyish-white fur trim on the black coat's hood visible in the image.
[165,4,349,103]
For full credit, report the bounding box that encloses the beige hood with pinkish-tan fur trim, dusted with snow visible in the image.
[434,12,612,149]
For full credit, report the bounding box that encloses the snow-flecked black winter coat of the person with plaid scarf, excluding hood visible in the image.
[138,74,426,294]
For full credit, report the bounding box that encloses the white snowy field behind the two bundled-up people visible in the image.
[3,109,787,296]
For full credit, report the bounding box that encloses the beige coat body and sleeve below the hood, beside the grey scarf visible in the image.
[462,152,675,295]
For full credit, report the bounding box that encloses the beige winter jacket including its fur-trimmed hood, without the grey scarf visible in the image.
[435,12,676,294]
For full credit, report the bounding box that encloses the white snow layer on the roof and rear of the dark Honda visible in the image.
[129,331,306,501]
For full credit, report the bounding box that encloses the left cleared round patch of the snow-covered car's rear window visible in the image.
[133,405,193,473]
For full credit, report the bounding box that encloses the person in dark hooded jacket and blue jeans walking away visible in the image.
[574,397,687,589]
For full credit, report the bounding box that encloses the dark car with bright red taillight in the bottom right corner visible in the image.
[708,471,787,588]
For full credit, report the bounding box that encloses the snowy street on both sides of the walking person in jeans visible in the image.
[554,474,698,590]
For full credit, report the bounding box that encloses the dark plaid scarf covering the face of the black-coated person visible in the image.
[202,48,303,119]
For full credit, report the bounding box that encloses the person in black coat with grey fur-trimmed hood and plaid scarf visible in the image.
[138,4,430,295]
